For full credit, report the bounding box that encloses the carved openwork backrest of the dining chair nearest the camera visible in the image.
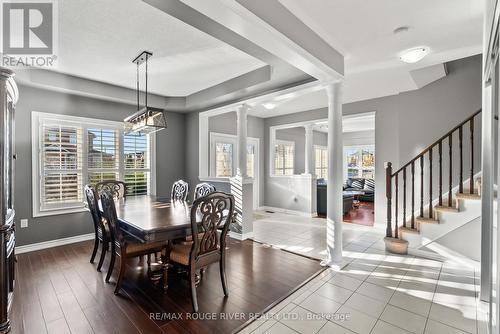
[190,192,234,263]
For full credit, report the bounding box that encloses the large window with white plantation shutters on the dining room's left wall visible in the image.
[32,112,153,216]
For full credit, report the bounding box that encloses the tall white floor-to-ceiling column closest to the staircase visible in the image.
[321,82,343,267]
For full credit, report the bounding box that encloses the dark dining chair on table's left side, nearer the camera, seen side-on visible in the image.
[101,190,168,294]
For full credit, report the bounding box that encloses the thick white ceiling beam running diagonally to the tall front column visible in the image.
[178,0,344,81]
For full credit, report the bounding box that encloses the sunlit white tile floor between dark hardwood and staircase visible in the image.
[240,214,484,334]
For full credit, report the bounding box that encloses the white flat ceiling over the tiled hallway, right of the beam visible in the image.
[248,0,483,117]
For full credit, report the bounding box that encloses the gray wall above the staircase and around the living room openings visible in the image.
[265,55,481,224]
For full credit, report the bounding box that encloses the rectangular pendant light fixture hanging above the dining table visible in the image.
[123,51,167,134]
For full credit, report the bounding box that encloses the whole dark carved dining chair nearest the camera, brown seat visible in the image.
[167,192,234,312]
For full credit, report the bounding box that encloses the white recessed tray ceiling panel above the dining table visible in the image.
[52,0,265,96]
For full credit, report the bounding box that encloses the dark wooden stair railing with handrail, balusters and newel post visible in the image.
[385,109,481,238]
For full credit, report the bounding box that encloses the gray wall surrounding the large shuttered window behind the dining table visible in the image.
[15,86,185,245]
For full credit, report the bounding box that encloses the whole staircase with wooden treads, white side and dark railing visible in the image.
[386,110,481,260]
